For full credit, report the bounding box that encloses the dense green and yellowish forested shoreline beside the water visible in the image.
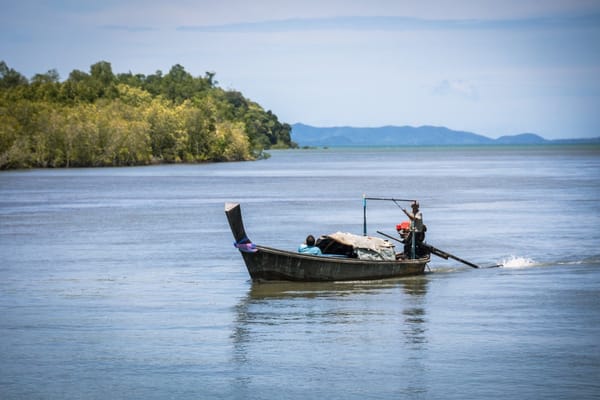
[0,61,295,169]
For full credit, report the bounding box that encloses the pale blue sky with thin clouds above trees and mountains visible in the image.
[0,0,600,139]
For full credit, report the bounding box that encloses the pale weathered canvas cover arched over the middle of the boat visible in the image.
[317,232,396,261]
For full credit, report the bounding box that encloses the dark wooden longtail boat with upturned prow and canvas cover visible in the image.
[225,203,430,282]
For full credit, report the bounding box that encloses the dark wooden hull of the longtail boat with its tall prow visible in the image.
[225,203,429,282]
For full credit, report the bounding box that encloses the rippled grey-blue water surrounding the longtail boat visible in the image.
[0,147,600,399]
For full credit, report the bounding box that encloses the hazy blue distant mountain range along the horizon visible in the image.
[292,123,600,147]
